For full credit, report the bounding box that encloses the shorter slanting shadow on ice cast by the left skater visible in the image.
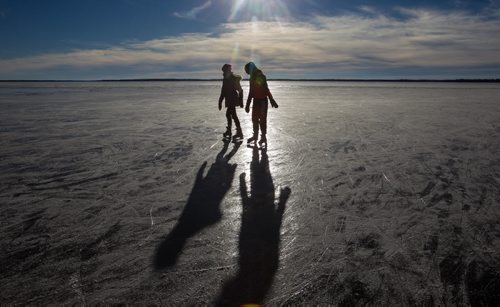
[154,141,241,270]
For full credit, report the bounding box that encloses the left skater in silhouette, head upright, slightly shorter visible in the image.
[219,64,243,138]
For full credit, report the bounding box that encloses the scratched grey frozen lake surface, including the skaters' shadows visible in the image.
[0,81,500,306]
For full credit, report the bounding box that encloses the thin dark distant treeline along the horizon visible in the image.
[0,78,500,83]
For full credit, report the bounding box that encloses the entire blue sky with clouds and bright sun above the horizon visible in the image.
[0,0,500,80]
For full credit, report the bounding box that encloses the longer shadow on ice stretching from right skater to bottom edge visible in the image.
[217,147,291,306]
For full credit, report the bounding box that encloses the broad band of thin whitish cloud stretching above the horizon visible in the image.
[0,9,500,78]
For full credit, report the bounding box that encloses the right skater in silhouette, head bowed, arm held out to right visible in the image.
[245,62,278,144]
